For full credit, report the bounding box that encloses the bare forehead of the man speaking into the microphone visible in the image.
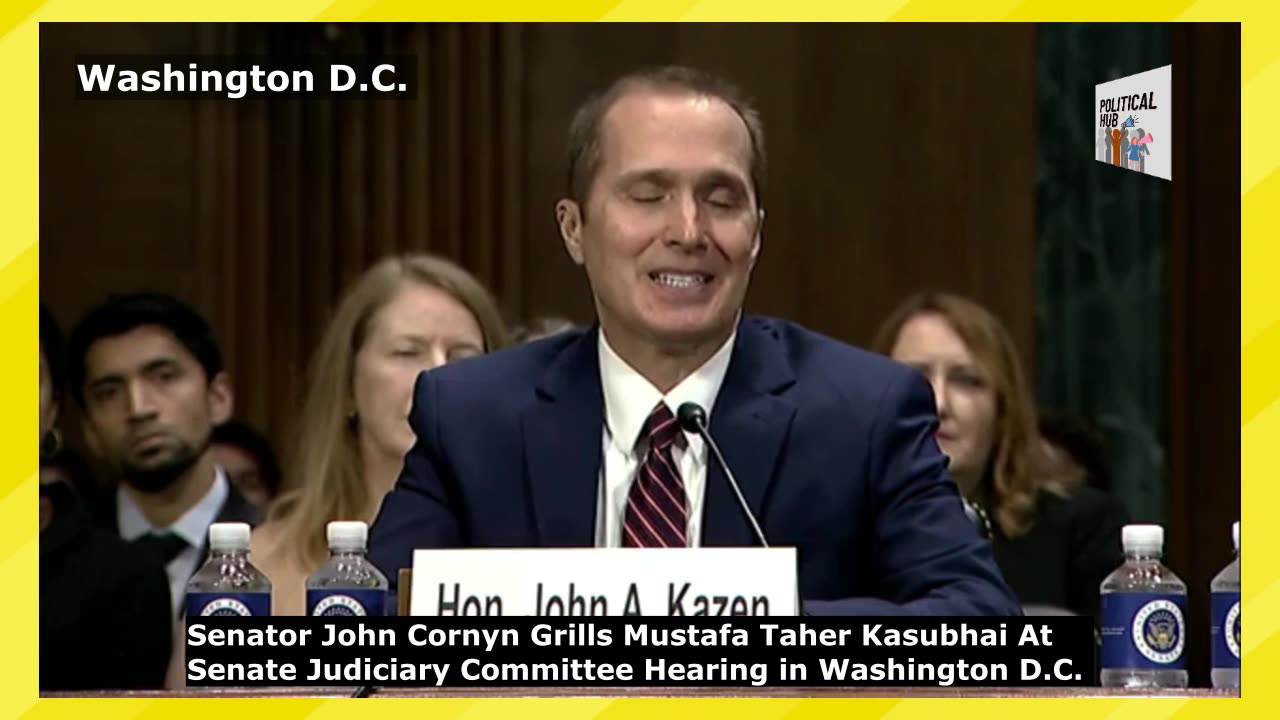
[600,87,751,174]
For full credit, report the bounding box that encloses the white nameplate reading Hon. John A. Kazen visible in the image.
[410,547,799,616]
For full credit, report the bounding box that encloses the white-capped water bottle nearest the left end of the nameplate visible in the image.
[307,521,387,616]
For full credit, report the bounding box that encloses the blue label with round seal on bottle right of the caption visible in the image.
[1101,592,1187,670]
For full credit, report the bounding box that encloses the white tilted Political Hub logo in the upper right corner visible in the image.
[1093,65,1172,179]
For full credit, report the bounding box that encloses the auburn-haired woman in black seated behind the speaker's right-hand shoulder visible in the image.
[874,292,1126,615]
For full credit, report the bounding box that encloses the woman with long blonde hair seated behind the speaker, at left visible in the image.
[252,255,507,615]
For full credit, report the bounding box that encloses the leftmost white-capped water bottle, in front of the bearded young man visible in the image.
[187,523,271,618]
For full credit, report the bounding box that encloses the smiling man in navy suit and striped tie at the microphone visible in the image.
[371,68,1019,615]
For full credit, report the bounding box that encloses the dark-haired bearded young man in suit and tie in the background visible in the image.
[68,293,257,618]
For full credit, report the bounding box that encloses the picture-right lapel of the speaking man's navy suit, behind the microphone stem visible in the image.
[701,318,796,546]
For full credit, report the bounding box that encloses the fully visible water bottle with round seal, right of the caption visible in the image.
[1101,525,1187,688]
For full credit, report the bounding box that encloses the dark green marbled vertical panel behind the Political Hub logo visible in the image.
[1036,23,1178,523]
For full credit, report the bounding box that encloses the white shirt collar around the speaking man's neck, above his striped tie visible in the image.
[599,329,737,455]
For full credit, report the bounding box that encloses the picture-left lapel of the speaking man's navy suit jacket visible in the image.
[521,329,604,547]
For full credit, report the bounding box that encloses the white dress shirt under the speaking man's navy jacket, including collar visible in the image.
[595,332,737,547]
